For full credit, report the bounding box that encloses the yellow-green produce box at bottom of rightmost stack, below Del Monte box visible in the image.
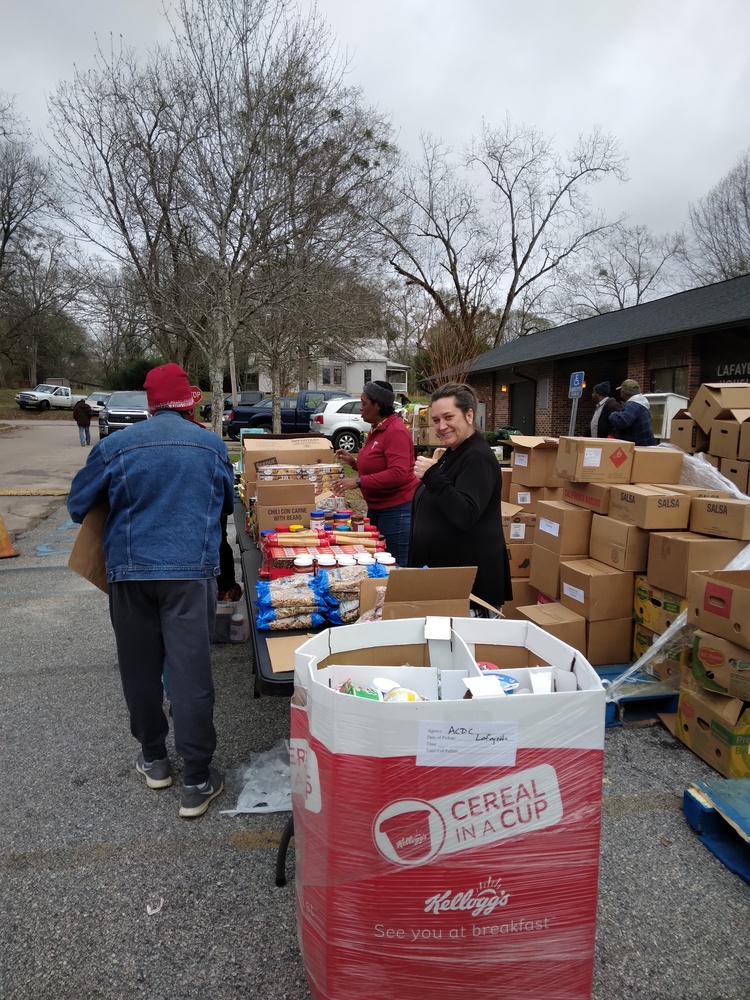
[677,674,750,778]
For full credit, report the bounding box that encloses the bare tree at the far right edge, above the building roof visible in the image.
[683,149,750,285]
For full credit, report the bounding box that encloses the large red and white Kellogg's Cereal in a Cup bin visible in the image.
[291,618,605,1000]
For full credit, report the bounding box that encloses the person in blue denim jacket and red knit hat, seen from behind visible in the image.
[68,364,234,817]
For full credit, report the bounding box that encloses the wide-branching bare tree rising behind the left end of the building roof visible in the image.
[382,118,624,368]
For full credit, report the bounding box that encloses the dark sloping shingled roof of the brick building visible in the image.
[471,274,750,372]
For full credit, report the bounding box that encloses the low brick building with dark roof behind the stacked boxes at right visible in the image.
[468,275,750,436]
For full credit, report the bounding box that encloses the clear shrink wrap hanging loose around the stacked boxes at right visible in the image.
[607,446,750,703]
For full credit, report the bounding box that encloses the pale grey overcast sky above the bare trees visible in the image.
[0,0,750,233]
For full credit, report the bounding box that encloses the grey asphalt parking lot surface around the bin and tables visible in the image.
[0,428,750,1000]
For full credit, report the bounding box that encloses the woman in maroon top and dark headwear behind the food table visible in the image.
[336,380,419,566]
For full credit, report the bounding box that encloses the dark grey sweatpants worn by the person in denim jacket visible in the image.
[109,578,216,785]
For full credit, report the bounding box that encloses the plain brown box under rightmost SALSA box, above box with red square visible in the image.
[646,531,745,597]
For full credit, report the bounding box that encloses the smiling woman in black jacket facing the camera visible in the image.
[409,382,512,616]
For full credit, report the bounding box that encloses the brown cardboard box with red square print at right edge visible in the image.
[688,569,750,648]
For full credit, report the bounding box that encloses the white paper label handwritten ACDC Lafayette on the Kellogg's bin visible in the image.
[417,722,518,767]
